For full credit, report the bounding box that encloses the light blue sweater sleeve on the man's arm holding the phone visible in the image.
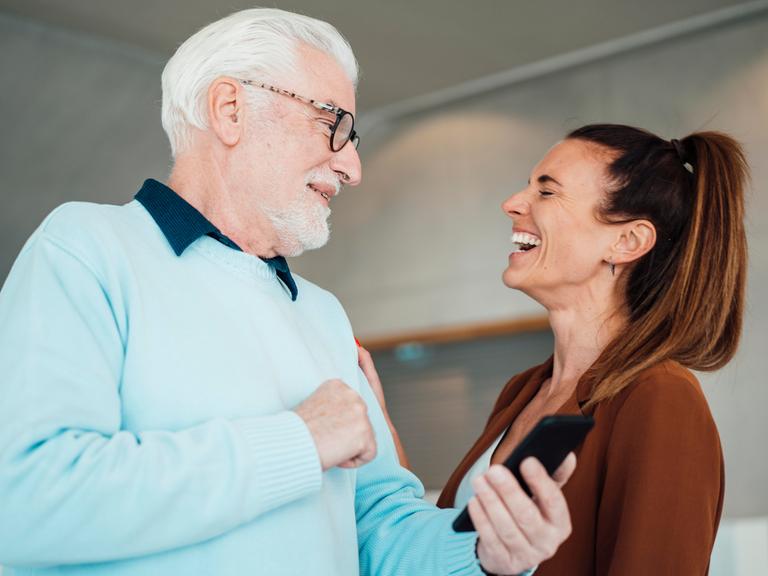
[355,372,532,576]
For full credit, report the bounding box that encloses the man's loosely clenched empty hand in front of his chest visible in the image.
[294,380,376,470]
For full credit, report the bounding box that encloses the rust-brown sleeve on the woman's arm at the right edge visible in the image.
[596,375,723,576]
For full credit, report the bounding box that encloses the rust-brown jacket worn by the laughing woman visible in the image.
[438,358,724,576]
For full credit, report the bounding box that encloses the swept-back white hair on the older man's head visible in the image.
[162,8,358,157]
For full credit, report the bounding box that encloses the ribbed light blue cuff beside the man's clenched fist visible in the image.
[233,411,323,511]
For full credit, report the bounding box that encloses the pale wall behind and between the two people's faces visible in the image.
[290,17,768,516]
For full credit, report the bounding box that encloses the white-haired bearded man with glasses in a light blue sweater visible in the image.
[0,10,569,576]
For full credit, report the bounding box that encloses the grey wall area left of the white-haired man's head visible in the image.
[0,14,169,282]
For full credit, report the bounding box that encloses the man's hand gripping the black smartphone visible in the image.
[469,453,576,574]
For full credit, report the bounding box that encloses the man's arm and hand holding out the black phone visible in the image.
[355,368,573,576]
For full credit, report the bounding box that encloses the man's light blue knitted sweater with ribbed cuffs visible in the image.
[0,201,480,576]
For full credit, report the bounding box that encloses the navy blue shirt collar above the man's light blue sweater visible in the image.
[136,178,299,301]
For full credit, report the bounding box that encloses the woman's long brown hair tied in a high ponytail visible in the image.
[568,124,749,404]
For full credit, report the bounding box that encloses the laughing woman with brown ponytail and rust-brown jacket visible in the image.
[361,125,748,576]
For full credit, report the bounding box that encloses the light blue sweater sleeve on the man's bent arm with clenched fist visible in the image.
[0,231,322,566]
